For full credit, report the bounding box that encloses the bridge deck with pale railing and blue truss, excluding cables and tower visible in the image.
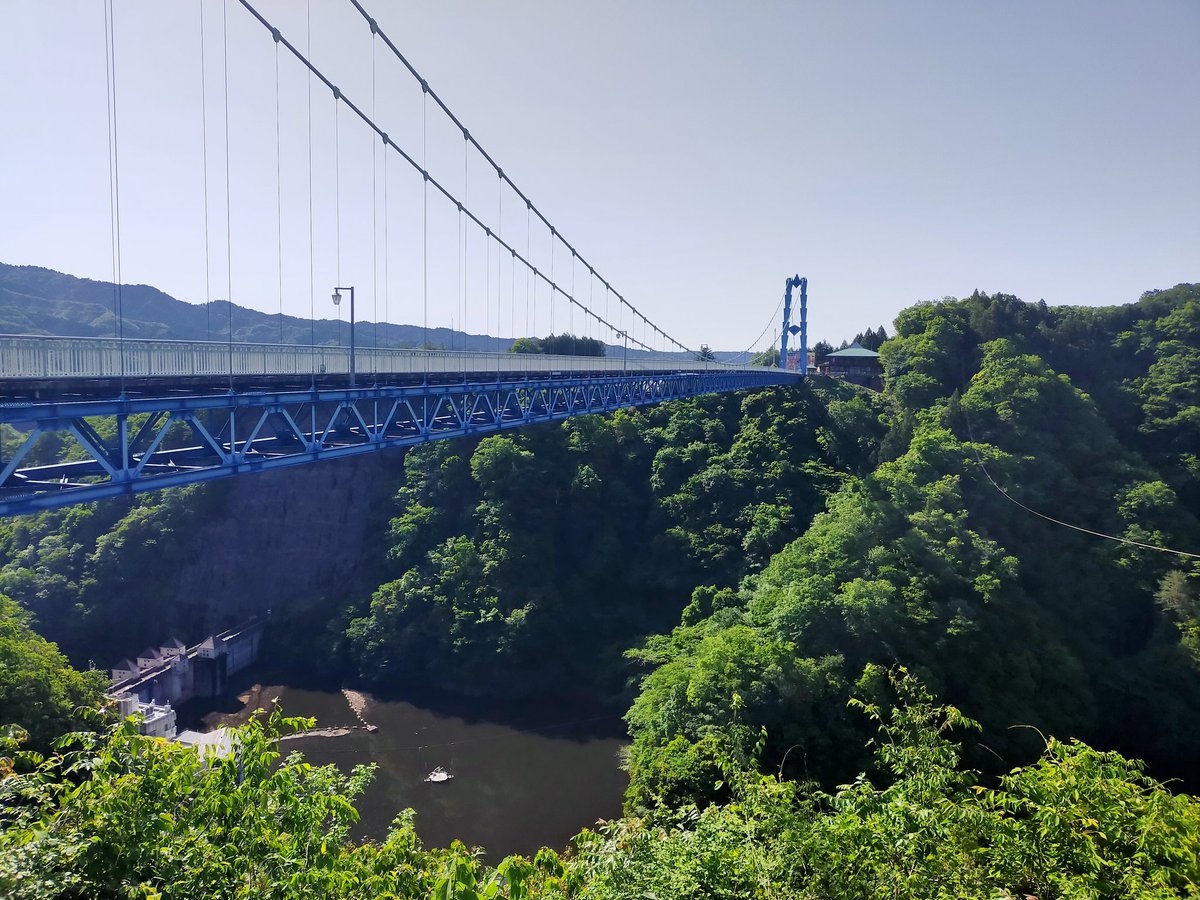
[0,337,798,515]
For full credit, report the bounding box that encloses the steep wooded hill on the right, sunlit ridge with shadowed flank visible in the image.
[628,286,1200,806]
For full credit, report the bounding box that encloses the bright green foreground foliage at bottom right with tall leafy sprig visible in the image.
[559,670,1200,900]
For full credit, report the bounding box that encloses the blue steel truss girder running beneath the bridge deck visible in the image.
[0,368,798,516]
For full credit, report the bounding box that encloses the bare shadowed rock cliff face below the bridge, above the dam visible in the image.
[174,450,404,629]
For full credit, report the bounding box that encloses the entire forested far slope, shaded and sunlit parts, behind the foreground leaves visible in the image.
[333,287,1200,805]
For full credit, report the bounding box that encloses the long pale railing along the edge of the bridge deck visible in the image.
[0,335,762,379]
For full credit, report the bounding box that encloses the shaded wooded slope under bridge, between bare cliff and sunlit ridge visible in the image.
[348,389,874,691]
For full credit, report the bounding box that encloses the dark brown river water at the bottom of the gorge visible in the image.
[250,688,626,864]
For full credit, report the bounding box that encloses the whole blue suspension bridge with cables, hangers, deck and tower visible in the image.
[0,0,808,516]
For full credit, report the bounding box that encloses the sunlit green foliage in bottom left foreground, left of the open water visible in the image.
[0,713,535,900]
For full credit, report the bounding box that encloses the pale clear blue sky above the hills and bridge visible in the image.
[0,0,1200,349]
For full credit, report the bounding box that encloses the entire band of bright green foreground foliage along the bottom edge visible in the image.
[0,672,1200,900]
